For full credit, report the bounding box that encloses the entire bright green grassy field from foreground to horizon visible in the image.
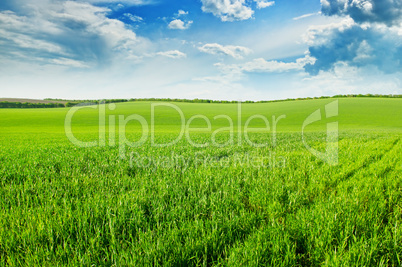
[0,98,402,266]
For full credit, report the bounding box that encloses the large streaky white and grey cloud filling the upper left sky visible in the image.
[0,1,147,67]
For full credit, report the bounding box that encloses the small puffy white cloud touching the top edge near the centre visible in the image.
[201,0,254,21]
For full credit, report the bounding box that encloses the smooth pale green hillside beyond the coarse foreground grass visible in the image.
[0,97,402,133]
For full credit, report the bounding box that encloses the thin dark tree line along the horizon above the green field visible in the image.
[0,94,402,108]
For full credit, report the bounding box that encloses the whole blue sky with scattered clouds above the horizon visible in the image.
[0,0,402,100]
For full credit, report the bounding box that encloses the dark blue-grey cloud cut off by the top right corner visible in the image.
[321,0,402,26]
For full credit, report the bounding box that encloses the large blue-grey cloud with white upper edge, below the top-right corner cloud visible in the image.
[305,21,402,75]
